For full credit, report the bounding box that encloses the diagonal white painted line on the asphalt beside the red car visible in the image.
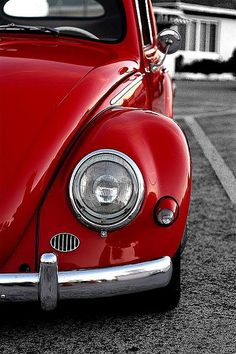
[183,116,236,204]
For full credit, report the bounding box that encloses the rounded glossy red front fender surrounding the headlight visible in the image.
[1,107,191,270]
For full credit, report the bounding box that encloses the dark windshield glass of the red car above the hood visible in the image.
[0,0,125,41]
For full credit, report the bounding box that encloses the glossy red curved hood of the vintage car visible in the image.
[0,36,135,263]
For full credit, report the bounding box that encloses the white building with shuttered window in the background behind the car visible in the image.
[152,0,236,71]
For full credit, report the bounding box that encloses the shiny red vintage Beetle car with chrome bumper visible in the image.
[0,0,191,310]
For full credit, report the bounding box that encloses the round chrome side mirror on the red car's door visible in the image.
[157,29,181,55]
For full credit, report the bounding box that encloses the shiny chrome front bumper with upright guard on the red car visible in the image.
[0,253,172,311]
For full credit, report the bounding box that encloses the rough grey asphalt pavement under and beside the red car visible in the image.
[0,82,236,354]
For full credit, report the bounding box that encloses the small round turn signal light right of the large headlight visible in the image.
[154,197,179,226]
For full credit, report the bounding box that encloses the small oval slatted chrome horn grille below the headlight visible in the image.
[50,233,80,252]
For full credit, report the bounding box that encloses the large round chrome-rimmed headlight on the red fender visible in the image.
[69,150,144,230]
